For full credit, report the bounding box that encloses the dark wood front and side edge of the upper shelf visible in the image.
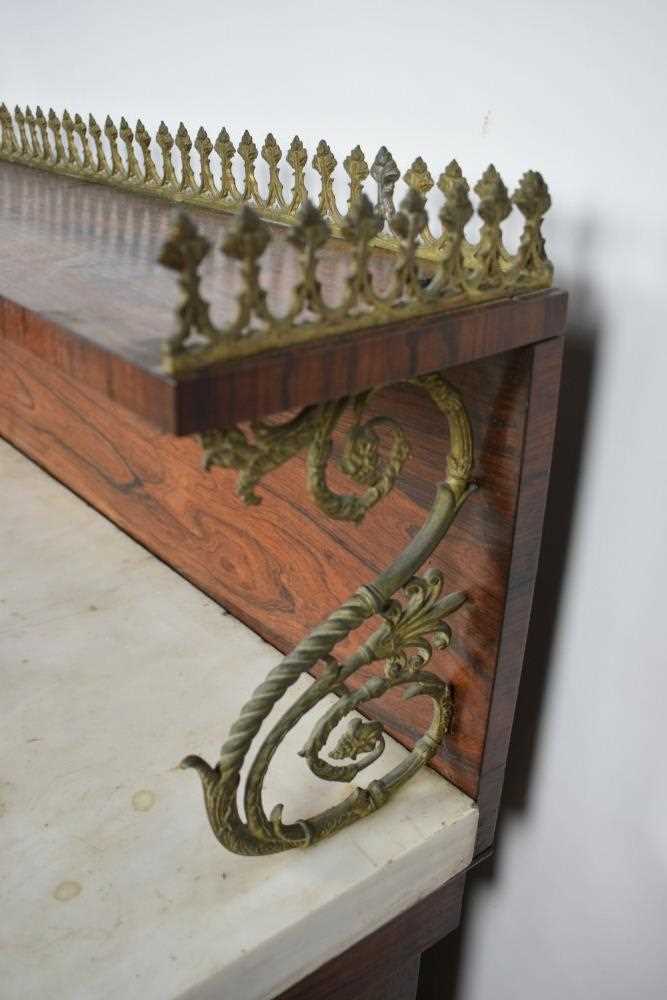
[0,290,567,435]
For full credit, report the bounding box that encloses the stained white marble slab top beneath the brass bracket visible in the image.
[0,442,477,1000]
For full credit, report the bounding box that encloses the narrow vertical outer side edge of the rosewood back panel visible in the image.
[475,338,563,852]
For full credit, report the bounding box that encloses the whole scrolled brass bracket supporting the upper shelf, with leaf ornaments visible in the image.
[182,374,473,855]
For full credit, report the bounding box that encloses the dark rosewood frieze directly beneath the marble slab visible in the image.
[275,872,466,1000]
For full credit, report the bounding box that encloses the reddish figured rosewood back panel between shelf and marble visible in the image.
[0,341,530,796]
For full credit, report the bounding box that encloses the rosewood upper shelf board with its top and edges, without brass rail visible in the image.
[0,164,567,434]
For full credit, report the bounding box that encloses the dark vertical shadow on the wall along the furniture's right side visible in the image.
[417,262,601,1000]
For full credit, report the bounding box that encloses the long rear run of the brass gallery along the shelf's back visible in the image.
[0,104,546,261]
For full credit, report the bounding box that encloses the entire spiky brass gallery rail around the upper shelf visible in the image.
[0,104,553,375]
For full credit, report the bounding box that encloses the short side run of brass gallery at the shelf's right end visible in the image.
[160,166,552,374]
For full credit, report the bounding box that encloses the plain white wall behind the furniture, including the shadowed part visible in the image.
[0,0,667,1000]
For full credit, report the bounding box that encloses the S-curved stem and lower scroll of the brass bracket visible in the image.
[183,374,473,854]
